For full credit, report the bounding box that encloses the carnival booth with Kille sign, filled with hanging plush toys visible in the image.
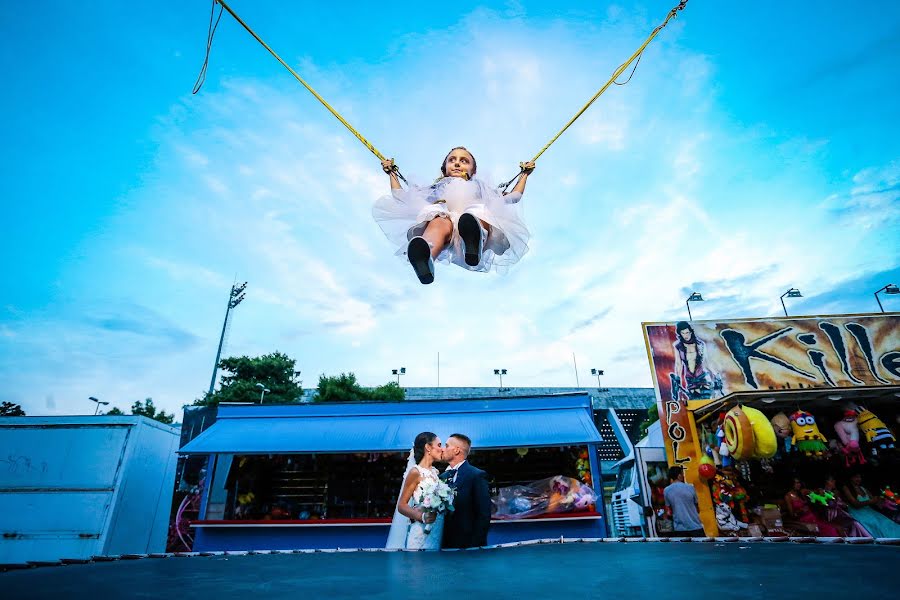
[643,313,900,538]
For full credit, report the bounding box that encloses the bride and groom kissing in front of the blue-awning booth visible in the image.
[386,431,491,550]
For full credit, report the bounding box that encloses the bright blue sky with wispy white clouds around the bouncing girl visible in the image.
[0,0,900,414]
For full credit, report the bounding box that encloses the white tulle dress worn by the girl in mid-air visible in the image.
[372,177,531,272]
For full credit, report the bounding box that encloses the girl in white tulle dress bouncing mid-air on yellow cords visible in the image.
[372,146,534,284]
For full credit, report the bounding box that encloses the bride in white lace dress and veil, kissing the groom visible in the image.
[386,431,444,550]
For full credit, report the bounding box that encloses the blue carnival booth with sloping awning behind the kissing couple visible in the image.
[181,393,606,551]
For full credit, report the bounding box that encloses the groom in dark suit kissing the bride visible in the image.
[441,433,491,548]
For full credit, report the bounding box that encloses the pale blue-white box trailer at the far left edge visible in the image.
[0,416,179,563]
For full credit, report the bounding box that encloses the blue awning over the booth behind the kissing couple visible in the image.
[181,394,602,454]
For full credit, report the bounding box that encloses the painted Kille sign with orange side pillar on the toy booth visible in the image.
[642,313,900,536]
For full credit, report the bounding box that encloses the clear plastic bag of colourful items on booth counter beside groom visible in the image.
[491,475,598,519]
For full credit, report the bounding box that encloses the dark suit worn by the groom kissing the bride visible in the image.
[441,461,491,548]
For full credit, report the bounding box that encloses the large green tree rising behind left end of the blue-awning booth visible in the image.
[194,352,303,406]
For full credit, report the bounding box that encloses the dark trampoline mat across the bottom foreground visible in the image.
[0,542,900,600]
